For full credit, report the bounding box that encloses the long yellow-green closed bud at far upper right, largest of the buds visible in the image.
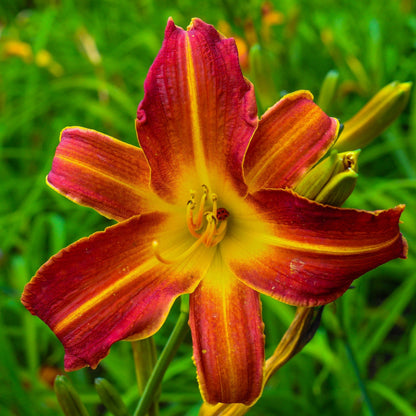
[335,81,412,151]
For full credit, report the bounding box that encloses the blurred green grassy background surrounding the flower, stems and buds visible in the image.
[0,0,416,416]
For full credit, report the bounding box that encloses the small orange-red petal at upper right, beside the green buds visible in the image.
[244,91,338,193]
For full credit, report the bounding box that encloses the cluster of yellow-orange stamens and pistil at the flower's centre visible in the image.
[153,185,230,264]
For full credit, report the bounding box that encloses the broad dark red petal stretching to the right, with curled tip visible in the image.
[228,190,407,306]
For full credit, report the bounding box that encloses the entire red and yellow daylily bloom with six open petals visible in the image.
[22,19,406,404]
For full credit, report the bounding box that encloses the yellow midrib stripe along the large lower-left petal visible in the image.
[53,258,158,333]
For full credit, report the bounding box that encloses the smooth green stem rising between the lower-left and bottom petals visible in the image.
[133,296,189,416]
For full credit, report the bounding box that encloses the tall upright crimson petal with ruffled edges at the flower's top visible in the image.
[136,19,257,202]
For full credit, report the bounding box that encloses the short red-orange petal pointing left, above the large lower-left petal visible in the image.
[48,127,155,221]
